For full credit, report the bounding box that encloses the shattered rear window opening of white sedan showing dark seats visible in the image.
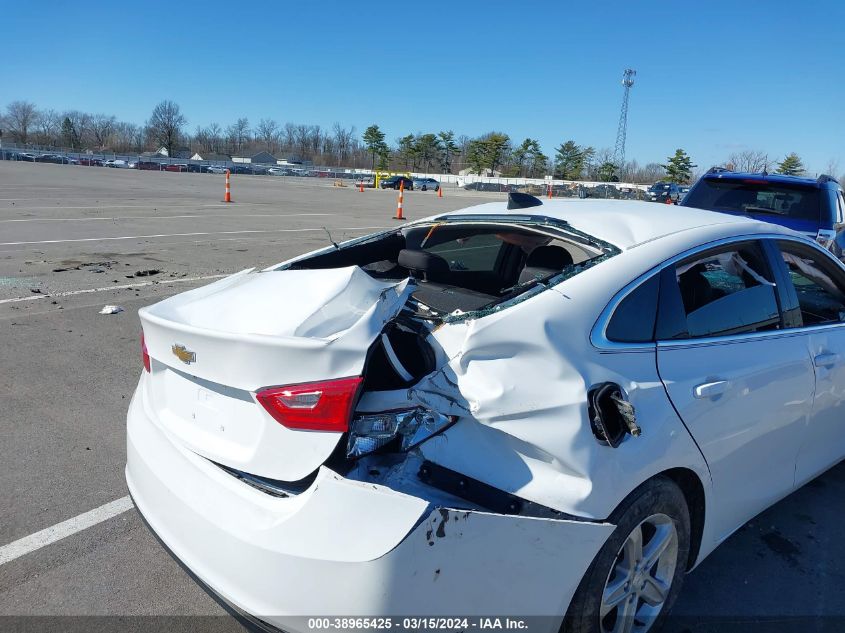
[291,222,604,313]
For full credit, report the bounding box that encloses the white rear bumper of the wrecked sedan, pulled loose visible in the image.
[126,378,613,630]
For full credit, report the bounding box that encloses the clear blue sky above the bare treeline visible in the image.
[0,0,845,173]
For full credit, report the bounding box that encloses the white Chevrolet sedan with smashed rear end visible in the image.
[126,194,845,632]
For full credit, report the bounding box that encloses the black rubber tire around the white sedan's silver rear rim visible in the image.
[561,476,690,633]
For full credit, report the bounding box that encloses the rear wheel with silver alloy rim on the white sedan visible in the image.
[562,477,690,633]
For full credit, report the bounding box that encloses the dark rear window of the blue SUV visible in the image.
[684,178,820,221]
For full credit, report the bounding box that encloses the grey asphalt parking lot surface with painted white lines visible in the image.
[0,162,845,631]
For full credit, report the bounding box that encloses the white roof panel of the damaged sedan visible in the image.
[439,199,792,250]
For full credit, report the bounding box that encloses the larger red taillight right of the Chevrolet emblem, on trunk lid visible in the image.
[255,376,364,433]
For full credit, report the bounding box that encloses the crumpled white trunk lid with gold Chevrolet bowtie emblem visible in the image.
[139,266,411,481]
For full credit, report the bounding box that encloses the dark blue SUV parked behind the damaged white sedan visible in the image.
[683,168,845,258]
